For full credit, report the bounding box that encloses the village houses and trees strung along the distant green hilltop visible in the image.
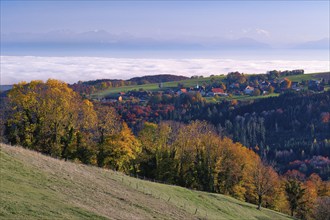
[103,70,328,103]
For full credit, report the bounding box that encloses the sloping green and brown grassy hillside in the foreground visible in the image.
[0,144,289,220]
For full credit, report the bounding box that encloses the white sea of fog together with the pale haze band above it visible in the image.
[1,49,330,85]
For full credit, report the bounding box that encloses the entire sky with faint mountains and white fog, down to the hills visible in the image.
[0,0,330,85]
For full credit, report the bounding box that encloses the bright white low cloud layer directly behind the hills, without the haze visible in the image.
[1,56,330,85]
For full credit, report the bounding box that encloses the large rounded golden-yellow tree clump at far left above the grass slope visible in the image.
[7,79,80,157]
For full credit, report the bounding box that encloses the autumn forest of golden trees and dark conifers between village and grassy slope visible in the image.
[1,75,330,219]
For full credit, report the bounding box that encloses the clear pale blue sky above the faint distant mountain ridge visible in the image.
[1,1,330,44]
